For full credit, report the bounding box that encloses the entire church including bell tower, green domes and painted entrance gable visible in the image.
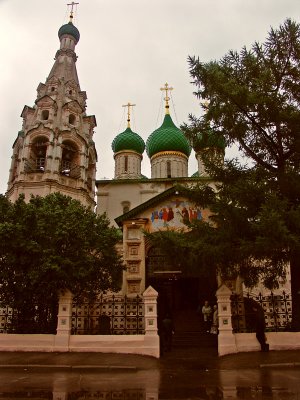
[7,12,225,324]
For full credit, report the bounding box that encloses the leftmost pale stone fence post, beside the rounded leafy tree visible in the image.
[54,290,73,351]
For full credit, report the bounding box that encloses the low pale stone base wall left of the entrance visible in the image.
[0,334,159,358]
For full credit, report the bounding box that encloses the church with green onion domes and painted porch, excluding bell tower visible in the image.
[96,89,225,313]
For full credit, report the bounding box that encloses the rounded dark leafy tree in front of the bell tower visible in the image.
[0,193,123,331]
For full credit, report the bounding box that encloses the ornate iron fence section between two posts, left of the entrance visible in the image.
[72,295,145,335]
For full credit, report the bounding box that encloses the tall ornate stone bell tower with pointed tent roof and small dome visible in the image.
[7,2,97,207]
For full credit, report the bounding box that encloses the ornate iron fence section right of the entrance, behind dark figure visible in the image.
[231,291,292,332]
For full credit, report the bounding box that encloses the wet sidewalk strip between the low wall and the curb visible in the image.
[0,347,300,371]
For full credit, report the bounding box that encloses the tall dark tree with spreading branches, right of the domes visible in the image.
[150,19,300,327]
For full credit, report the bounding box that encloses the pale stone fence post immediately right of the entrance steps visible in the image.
[216,284,237,356]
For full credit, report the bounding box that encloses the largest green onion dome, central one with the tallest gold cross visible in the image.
[146,114,191,158]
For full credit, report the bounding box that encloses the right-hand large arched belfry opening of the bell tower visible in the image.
[60,140,80,179]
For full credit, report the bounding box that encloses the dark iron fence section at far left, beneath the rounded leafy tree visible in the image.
[0,304,58,334]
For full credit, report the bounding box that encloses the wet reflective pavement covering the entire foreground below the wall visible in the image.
[0,348,300,400]
